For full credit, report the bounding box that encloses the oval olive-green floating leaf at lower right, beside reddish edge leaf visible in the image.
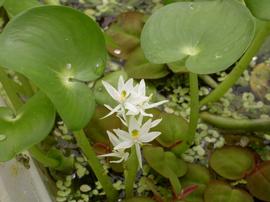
[210,146,255,180]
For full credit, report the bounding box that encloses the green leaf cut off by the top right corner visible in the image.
[245,0,270,20]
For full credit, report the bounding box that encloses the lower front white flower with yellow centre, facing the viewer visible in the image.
[114,116,161,168]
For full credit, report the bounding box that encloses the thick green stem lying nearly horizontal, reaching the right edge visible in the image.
[200,112,270,132]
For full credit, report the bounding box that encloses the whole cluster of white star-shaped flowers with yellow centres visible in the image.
[100,76,167,167]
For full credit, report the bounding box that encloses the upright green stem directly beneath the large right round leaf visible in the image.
[188,72,199,143]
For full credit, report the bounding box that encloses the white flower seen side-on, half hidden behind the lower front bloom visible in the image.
[99,131,129,163]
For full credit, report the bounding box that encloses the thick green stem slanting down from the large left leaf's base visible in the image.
[74,130,117,202]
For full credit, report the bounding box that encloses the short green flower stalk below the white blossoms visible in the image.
[124,146,138,198]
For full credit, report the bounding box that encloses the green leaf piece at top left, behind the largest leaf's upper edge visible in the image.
[4,0,41,18]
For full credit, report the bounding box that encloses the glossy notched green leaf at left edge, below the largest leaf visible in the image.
[0,92,55,161]
